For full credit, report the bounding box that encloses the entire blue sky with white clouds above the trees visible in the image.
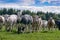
[0,0,60,13]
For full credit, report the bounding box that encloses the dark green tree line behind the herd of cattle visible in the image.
[0,8,60,20]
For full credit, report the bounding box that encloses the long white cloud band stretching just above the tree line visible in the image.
[0,3,60,14]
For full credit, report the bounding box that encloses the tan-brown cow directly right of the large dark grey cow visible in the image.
[32,15,42,31]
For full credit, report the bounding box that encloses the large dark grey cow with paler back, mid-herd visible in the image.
[21,14,33,32]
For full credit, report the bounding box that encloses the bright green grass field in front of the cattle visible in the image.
[0,30,60,40]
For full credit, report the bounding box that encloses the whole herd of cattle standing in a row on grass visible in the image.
[0,14,60,33]
